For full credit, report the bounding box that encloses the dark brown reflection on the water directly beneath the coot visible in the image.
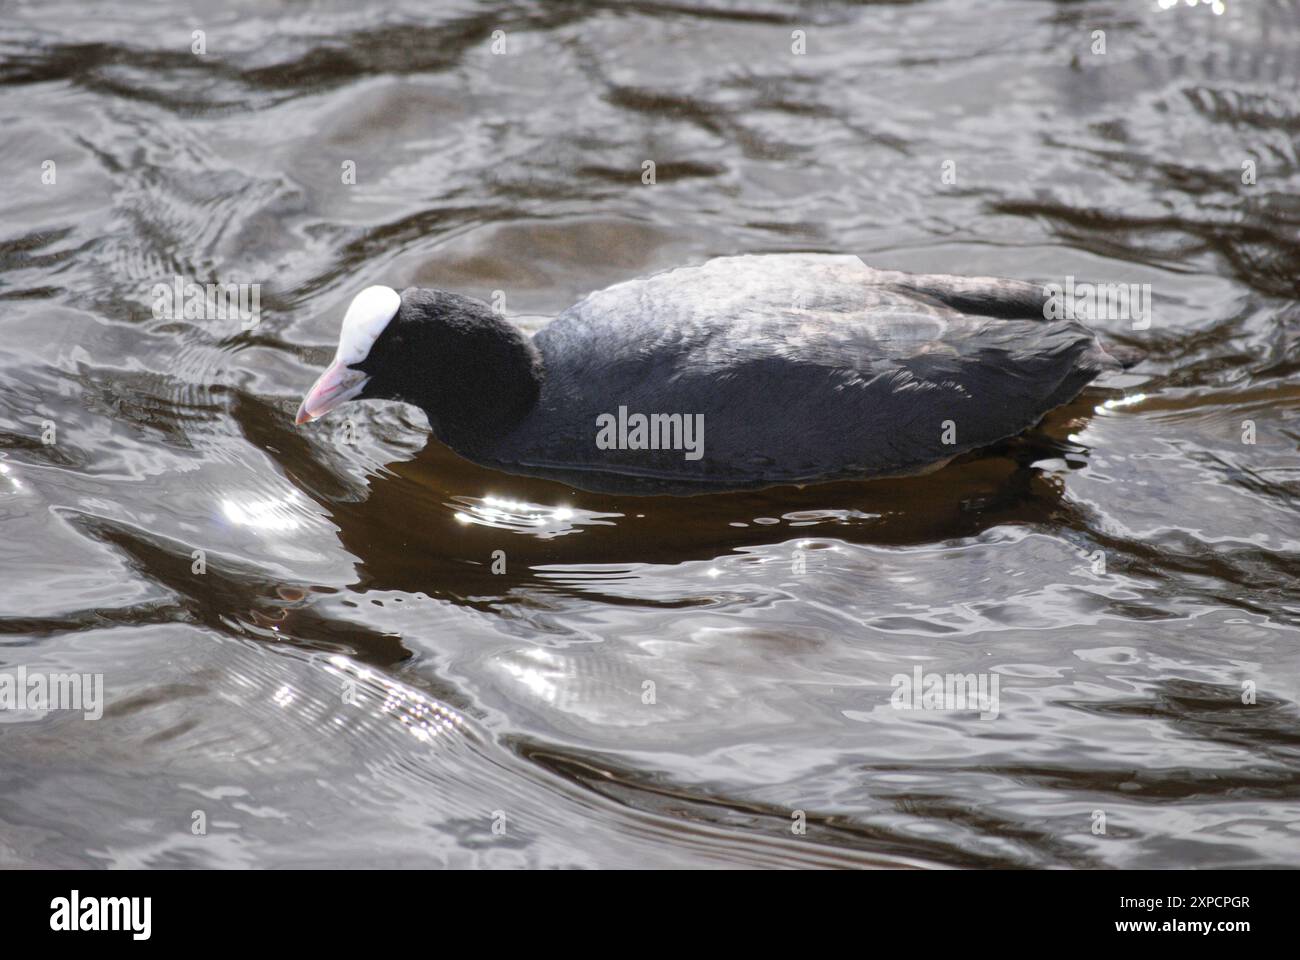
[314,394,1099,604]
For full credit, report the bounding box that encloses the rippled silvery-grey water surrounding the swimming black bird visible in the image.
[0,0,1300,866]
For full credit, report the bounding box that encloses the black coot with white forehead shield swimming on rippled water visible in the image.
[298,254,1119,494]
